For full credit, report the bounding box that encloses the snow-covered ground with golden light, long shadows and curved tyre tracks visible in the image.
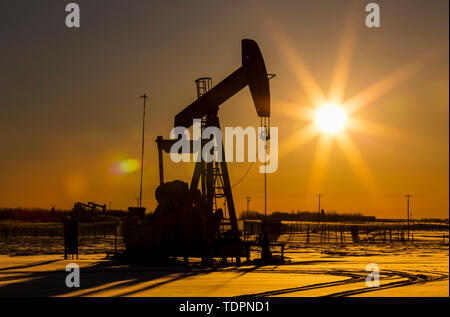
[0,232,449,297]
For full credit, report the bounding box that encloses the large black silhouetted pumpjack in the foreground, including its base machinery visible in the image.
[122,39,270,263]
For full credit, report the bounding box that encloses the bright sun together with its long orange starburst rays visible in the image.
[272,14,435,194]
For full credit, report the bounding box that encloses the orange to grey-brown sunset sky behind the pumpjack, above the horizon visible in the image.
[0,0,449,218]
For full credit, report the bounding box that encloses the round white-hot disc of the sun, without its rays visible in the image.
[315,104,347,134]
